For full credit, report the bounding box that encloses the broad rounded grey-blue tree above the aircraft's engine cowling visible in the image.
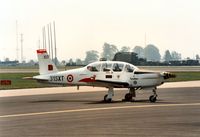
[144,44,161,61]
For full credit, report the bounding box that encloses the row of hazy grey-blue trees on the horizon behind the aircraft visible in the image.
[65,43,199,65]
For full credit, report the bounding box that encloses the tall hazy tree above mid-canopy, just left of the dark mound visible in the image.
[102,43,118,60]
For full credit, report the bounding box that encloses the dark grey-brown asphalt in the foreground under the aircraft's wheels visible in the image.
[0,87,200,137]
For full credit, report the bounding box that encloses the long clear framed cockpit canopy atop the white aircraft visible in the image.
[86,61,138,72]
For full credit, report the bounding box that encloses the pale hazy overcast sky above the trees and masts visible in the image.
[0,0,200,61]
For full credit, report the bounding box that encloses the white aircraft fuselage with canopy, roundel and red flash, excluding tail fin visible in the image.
[33,61,164,88]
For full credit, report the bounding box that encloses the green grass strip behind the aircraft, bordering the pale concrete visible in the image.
[0,72,200,90]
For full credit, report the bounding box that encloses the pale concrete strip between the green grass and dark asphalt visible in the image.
[0,81,200,98]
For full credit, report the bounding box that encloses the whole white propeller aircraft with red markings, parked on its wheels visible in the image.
[32,49,175,102]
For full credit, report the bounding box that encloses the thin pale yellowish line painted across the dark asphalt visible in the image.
[0,103,200,118]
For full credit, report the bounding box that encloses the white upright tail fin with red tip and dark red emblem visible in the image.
[37,49,58,75]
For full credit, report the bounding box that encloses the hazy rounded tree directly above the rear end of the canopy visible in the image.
[85,50,99,64]
